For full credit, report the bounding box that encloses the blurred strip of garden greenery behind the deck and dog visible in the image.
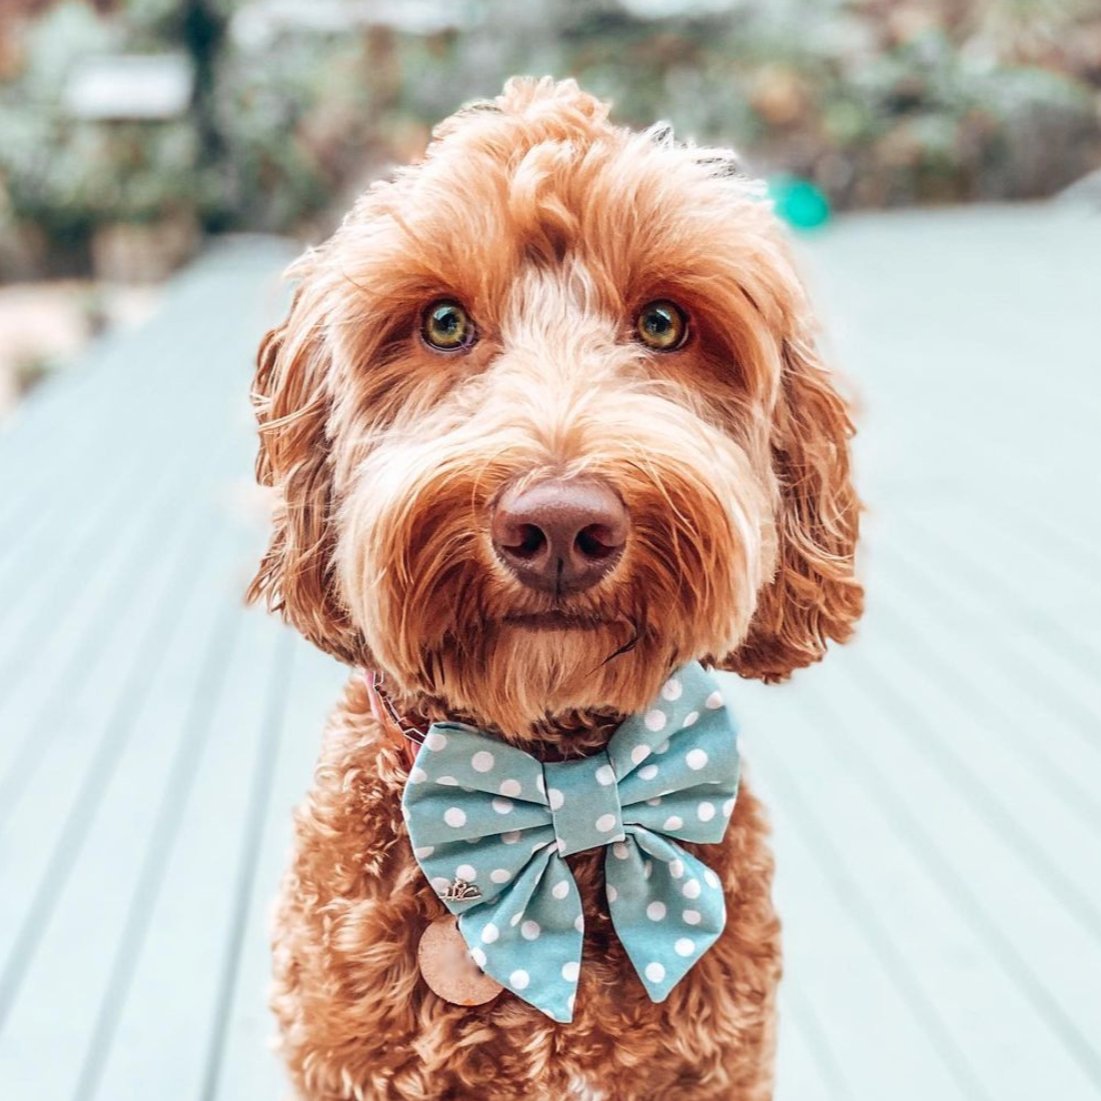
[0,0,1101,409]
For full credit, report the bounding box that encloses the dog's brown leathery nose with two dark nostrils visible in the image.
[490,478,630,596]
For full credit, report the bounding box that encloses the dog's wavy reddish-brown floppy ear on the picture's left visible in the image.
[248,279,362,664]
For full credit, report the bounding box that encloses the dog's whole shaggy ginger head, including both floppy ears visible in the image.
[252,81,861,734]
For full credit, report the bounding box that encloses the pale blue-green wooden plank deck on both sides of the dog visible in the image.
[0,207,1101,1101]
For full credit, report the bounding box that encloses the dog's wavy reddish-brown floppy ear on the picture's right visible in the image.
[723,321,864,682]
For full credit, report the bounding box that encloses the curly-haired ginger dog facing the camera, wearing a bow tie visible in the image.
[250,78,863,1101]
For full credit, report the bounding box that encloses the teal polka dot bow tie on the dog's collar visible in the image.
[402,664,738,1022]
